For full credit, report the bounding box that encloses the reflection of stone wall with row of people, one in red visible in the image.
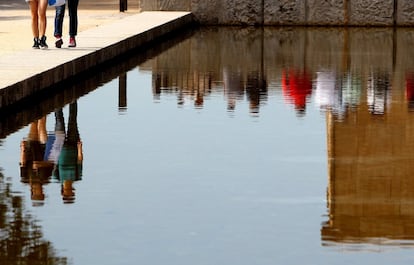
[145,27,414,115]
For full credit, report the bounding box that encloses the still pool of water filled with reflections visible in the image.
[0,28,414,265]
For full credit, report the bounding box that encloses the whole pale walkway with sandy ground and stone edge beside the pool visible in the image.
[0,0,190,108]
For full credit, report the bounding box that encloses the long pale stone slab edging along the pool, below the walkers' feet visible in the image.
[0,11,192,108]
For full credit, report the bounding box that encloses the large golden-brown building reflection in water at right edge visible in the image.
[321,67,414,246]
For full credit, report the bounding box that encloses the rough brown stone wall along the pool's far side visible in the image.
[138,0,414,26]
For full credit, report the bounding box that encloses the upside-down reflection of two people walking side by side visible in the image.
[20,101,83,205]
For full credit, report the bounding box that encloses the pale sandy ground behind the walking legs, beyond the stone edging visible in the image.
[0,0,139,56]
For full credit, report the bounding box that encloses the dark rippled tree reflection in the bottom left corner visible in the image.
[0,168,68,265]
